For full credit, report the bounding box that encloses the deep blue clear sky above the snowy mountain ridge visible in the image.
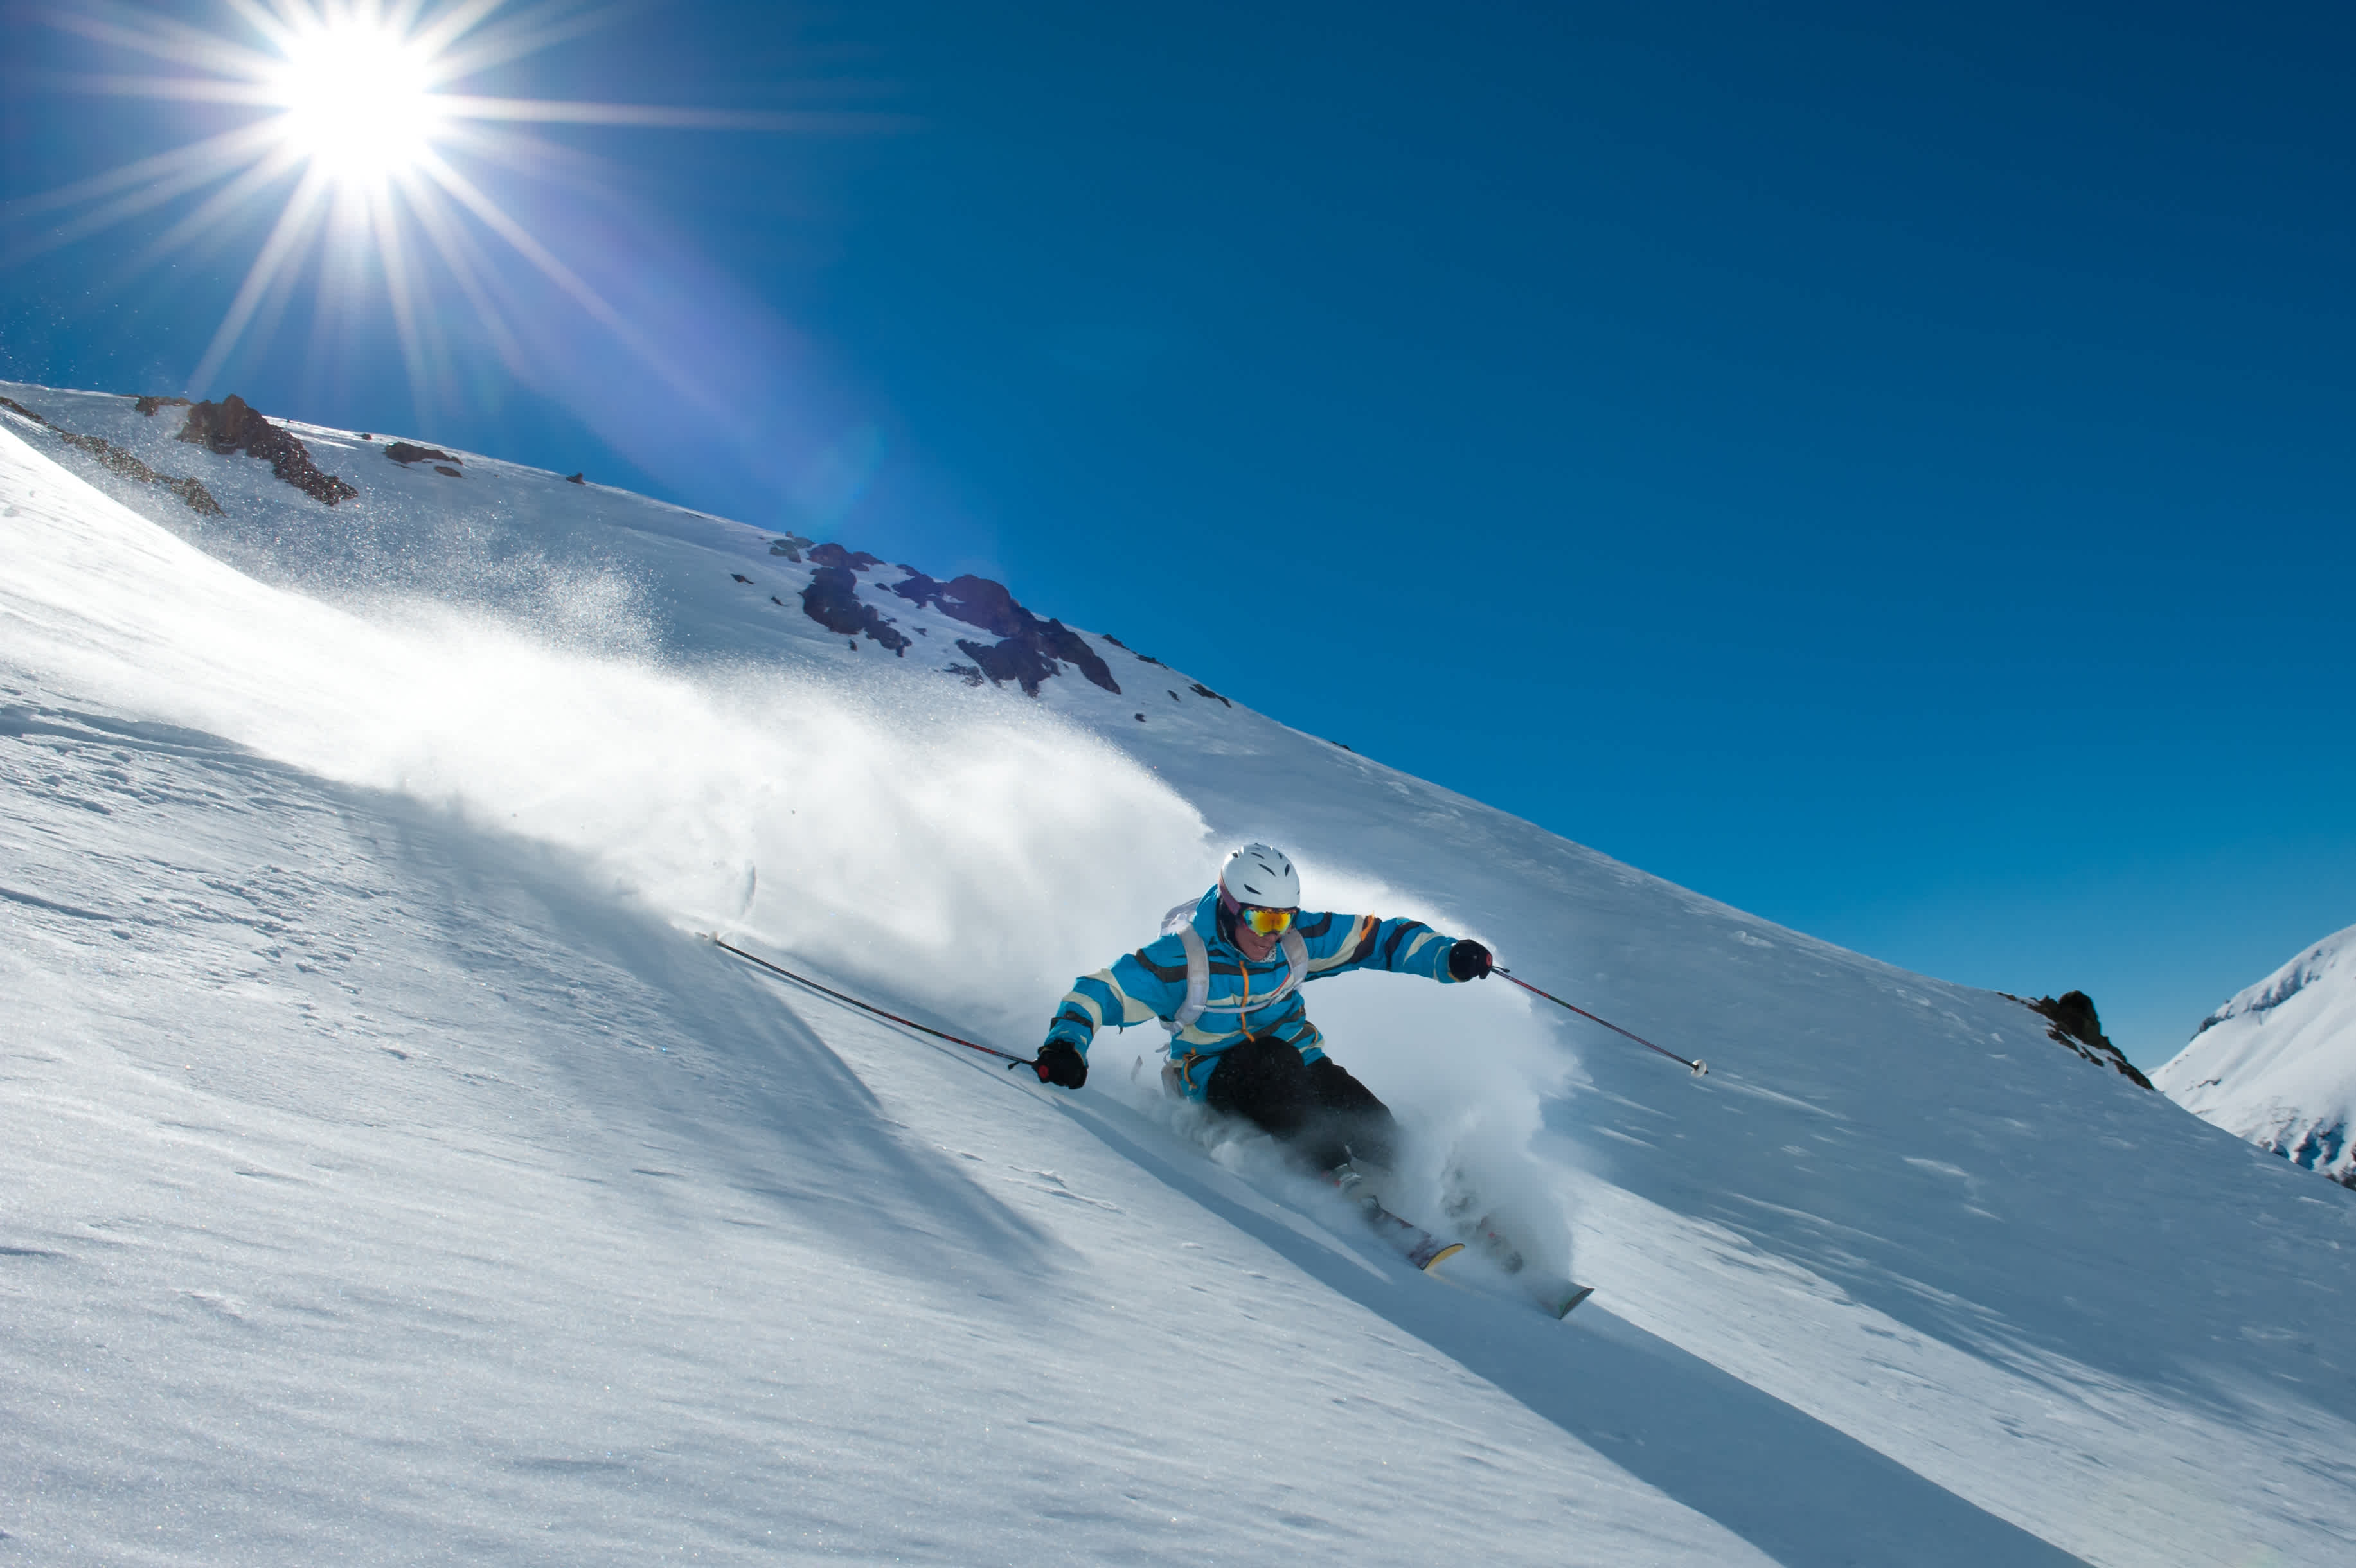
[0,0,2356,1064]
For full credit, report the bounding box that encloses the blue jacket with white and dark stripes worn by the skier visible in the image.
[1046,887,1456,1100]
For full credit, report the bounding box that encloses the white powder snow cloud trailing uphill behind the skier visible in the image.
[0,421,1211,1046]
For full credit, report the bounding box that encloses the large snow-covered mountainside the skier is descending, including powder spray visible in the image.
[13,389,2356,1565]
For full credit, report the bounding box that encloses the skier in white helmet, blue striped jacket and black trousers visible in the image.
[1037,843,1492,1186]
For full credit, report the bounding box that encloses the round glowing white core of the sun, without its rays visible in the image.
[269,21,443,181]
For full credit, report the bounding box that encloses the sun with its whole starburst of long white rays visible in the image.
[10,0,888,409]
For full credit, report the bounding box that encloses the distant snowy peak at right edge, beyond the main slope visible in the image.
[2151,925,2356,1186]
